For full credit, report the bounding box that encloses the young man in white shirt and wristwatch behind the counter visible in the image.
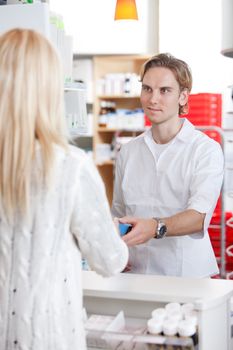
[112,54,223,277]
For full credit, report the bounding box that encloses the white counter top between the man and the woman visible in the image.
[83,271,233,310]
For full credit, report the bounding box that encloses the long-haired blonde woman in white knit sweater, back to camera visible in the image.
[0,29,128,350]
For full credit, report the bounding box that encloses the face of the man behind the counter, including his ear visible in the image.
[141,67,188,125]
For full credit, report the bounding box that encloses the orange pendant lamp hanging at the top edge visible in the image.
[114,0,138,20]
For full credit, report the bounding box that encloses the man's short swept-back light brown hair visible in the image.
[140,53,192,114]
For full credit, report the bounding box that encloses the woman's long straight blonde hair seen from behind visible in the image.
[0,29,67,221]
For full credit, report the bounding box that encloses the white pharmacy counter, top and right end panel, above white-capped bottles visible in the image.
[83,271,233,350]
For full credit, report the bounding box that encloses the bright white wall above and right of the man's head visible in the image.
[159,0,233,93]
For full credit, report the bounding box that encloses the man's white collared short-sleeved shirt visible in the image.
[112,119,223,277]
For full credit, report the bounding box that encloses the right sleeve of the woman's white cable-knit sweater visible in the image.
[71,157,128,276]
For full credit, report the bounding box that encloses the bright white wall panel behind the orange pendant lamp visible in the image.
[50,0,158,54]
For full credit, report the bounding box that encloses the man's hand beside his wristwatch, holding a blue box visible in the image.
[119,216,157,247]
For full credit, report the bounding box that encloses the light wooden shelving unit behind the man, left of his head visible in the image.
[93,55,148,204]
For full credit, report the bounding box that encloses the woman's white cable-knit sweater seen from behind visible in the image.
[0,146,128,350]
